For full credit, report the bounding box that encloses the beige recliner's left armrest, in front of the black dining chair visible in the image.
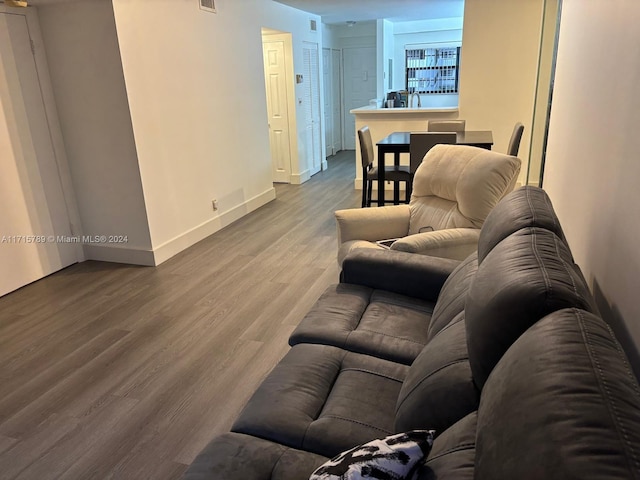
[335,205,410,247]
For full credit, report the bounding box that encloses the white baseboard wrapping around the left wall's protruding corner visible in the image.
[83,187,276,266]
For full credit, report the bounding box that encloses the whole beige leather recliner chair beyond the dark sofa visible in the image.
[335,145,521,265]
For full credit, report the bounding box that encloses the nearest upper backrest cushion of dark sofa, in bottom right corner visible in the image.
[475,309,640,480]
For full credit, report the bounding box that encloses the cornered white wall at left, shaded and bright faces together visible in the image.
[30,0,324,264]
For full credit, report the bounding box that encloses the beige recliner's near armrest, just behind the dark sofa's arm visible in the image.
[391,228,480,260]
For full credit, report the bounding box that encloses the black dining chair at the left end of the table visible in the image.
[358,126,411,208]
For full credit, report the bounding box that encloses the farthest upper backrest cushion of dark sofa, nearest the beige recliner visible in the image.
[478,186,566,263]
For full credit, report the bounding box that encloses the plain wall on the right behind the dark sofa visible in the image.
[543,0,640,375]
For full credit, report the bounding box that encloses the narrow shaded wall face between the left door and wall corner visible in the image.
[38,1,153,264]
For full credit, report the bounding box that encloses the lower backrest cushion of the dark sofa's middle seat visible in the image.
[395,312,479,434]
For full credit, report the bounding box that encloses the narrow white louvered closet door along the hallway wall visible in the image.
[302,42,322,175]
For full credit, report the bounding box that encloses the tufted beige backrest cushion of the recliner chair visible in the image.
[409,145,521,234]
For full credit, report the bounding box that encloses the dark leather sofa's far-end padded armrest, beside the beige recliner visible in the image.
[340,248,460,302]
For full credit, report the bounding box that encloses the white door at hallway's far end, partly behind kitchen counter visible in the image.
[343,47,377,150]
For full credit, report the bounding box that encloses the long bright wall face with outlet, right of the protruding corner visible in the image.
[113,0,321,261]
